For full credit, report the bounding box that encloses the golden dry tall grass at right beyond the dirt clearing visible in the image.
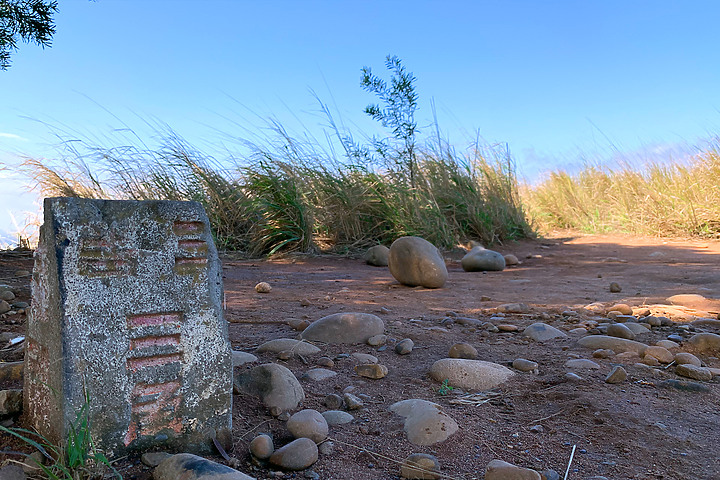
[523,145,720,237]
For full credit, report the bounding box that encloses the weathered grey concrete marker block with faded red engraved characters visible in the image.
[24,198,232,454]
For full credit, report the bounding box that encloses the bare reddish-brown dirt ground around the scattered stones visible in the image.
[0,235,720,480]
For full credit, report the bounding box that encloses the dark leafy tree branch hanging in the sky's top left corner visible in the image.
[0,0,57,70]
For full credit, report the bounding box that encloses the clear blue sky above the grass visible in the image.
[0,0,720,246]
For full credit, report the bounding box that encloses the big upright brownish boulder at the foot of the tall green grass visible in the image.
[388,237,448,288]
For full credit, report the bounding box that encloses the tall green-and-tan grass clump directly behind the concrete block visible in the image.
[16,118,532,256]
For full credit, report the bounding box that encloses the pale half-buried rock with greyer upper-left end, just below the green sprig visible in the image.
[390,398,458,445]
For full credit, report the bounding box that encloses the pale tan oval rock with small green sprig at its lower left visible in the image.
[430,358,514,390]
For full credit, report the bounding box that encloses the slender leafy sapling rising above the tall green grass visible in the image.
[360,55,418,188]
